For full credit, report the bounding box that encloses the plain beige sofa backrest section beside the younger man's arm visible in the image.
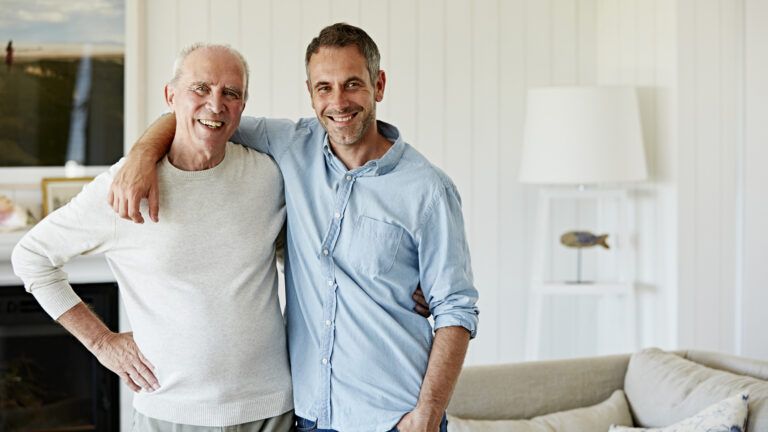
[448,355,629,420]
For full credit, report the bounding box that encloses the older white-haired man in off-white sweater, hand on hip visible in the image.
[13,45,293,432]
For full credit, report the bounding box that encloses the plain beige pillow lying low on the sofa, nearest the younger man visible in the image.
[448,390,632,432]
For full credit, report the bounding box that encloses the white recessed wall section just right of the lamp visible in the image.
[597,0,677,354]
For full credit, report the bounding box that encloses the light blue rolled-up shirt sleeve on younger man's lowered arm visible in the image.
[419,184,479,338]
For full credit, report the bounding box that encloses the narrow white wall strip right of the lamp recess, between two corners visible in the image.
[677,0,744,352]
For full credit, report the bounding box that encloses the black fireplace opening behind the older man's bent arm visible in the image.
[0,283,120,432]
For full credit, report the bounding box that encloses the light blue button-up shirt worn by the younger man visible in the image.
[233,117,478,432]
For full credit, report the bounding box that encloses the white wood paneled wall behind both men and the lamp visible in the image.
[126,0,760,364]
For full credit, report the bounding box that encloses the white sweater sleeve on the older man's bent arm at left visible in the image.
[11,174,116,319]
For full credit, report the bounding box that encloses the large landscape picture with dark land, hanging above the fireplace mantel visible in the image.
[0,0,126,168]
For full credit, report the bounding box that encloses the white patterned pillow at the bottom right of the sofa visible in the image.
[609,395,748,432]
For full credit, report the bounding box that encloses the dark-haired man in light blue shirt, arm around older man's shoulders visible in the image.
[111,24,477,432]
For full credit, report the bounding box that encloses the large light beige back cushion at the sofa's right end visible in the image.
[624,348,768,432]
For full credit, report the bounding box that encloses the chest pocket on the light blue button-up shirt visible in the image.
[349,215,403,275]
